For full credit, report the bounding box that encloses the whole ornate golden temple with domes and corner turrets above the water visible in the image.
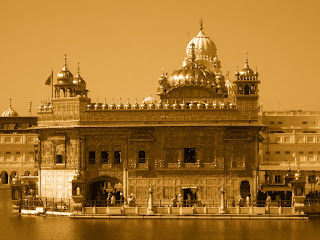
[37,26,263,204]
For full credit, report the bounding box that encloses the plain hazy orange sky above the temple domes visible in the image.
[0,0,320,116]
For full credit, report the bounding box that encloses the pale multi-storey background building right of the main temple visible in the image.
[260,110,320,194]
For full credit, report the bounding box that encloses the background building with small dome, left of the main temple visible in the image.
[0,100,38,187]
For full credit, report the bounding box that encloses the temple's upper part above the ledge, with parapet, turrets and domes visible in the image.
[38,24,260,127]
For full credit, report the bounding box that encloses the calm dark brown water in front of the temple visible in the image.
[0,189,320,240]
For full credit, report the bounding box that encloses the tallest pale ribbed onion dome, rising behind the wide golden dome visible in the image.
[186,27,217,61]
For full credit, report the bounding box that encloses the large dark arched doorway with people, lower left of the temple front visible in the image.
[86,176,122,206]
